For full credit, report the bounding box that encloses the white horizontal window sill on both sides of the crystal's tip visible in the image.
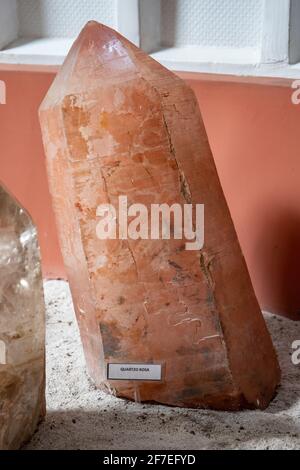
[0,38,300,79]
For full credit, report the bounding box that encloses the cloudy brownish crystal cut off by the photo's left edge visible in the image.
[0,187,45,450]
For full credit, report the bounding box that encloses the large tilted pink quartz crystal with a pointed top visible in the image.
[40,22,280,409]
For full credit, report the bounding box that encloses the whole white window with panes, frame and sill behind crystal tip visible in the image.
[0,0,300,78]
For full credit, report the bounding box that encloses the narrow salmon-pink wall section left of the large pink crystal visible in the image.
[0,71,64,277]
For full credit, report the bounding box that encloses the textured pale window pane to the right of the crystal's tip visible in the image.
[161,0,264,48]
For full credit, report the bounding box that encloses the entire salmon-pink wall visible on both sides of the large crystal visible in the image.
[0,71,300,319]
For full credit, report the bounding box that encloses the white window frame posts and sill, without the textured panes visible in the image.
[0,0,300,79]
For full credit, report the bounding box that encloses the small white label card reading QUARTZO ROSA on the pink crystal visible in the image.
[107,363,161,381]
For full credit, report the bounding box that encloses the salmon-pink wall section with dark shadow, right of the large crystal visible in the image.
[190,82,300,319]
